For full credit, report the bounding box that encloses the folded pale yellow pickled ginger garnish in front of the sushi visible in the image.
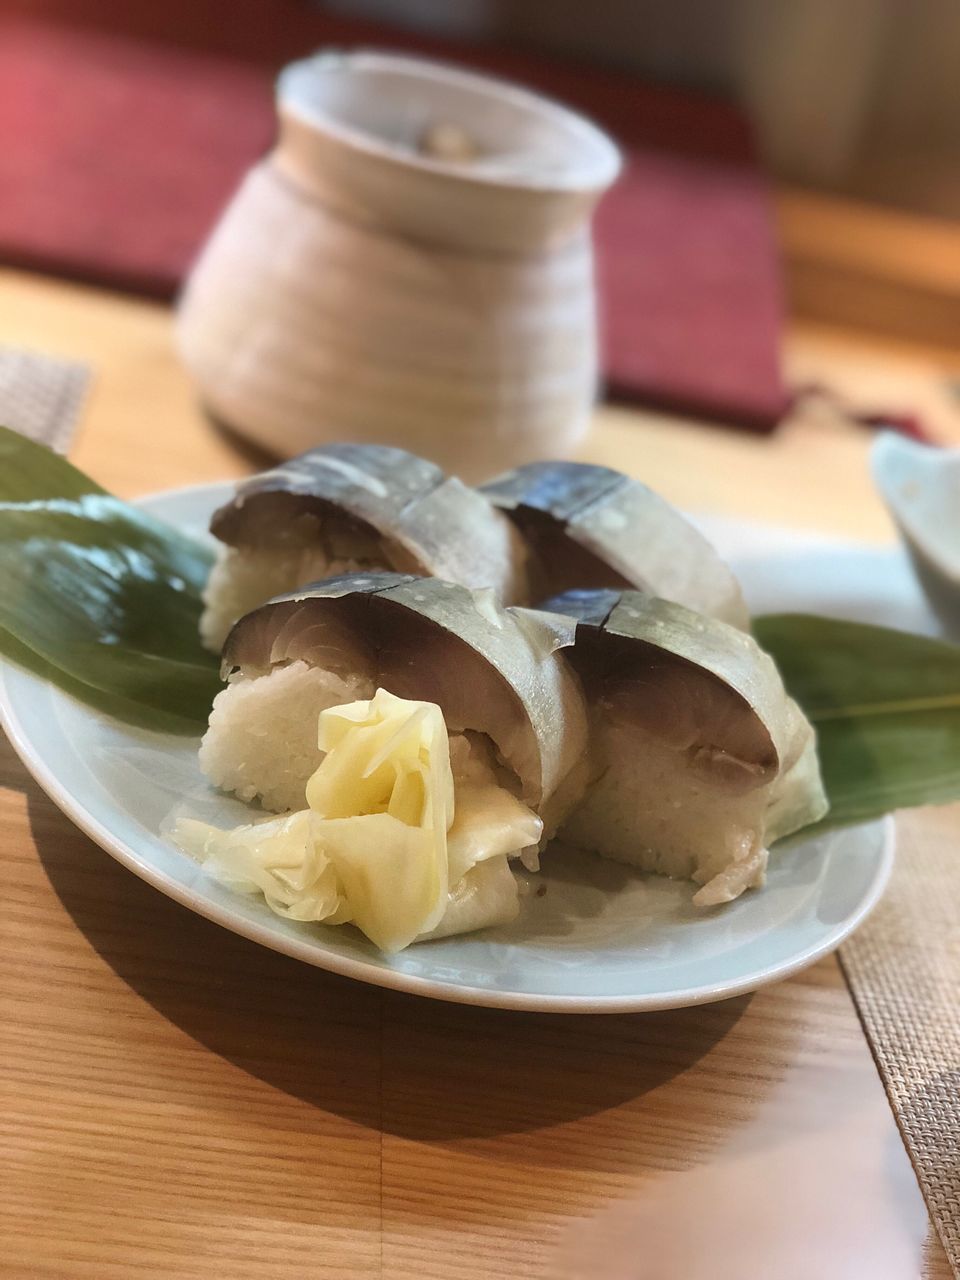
[173,689,543,951]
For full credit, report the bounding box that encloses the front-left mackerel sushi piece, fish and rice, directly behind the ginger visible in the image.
[200,573,588,835]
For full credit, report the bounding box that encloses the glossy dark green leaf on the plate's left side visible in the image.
[0,428,219,732]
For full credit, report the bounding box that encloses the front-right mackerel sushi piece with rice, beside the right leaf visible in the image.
[544,590,827,906]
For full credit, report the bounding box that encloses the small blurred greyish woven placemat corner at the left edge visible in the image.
[0,347,90,453]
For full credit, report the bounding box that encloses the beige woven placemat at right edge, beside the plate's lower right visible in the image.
[840,805,960,1276]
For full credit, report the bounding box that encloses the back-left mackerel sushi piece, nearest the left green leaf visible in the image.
[200,444,527,652]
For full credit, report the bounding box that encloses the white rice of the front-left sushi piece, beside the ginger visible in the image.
[200,662,375,813]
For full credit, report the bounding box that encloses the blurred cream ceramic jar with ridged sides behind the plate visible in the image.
[178,52,620,477]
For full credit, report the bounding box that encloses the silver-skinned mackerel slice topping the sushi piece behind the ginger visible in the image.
[223,573,588,826]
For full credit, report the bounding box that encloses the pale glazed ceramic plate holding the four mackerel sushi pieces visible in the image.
[0,485,892,1012]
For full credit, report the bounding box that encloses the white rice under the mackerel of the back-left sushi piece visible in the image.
[200,543,376,653]
